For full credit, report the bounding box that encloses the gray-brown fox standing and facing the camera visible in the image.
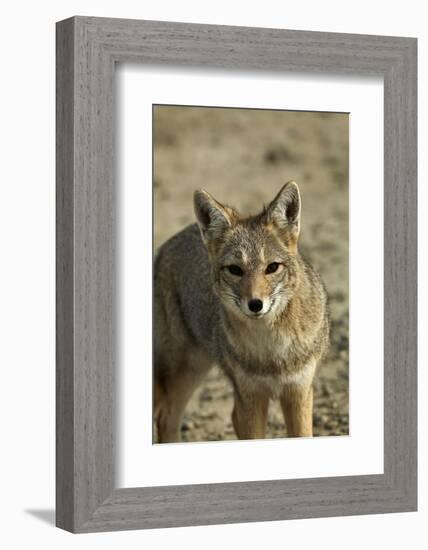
[153,181,330,443]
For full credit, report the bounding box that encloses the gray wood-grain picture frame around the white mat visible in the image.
[56,17,417,533]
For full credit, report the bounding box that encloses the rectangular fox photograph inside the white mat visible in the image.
[153,105,349,443]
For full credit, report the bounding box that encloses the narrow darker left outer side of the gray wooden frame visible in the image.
[56,18,75,530]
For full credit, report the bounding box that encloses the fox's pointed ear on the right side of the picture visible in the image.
[266,181,301,239]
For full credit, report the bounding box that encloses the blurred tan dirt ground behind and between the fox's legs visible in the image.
[153,106,349,441]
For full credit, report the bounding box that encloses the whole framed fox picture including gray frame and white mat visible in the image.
[57,17,417,532]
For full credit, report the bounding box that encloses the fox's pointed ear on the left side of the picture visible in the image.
[193,189,236,243]
